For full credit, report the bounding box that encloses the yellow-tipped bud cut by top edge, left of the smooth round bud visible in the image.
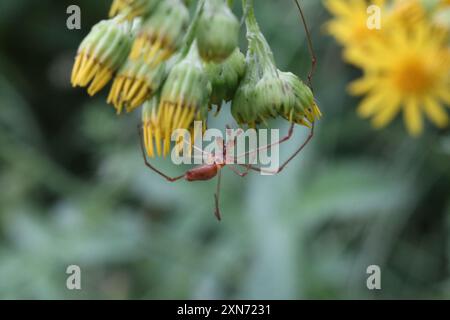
[130,0,189,63]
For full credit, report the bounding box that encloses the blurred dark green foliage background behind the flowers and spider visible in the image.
[0,0,450,299]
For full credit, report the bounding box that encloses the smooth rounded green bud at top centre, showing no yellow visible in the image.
[197,0,240,62]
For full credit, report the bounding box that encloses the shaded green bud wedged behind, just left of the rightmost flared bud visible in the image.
[205,48,246,108]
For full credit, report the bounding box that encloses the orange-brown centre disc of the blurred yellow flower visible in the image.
[394,59,433,94]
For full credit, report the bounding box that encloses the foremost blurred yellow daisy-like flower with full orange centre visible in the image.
[350,21,450,136]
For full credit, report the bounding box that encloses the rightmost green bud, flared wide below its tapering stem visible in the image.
[231,0,321,126]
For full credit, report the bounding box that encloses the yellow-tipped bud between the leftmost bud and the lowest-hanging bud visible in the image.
[108,57,165,114]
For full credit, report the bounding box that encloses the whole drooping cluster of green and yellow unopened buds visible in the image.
[72,0,320,157]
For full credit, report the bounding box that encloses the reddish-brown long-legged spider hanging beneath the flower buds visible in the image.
[138,0,317,221]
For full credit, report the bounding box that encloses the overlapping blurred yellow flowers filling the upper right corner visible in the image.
[325,0,450,136]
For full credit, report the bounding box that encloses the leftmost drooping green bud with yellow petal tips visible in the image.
[71,17,133,96]
